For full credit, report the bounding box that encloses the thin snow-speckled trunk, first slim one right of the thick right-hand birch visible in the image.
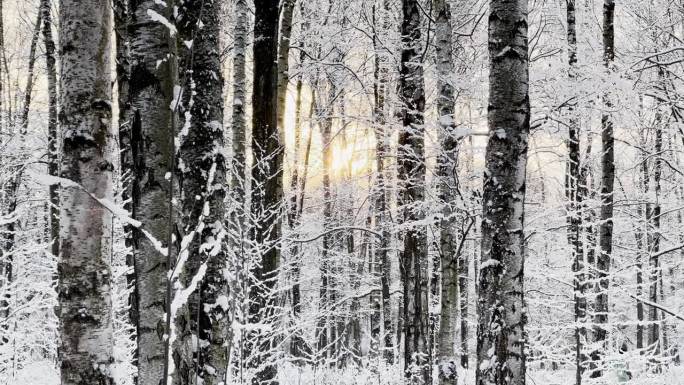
[565,0,587,385]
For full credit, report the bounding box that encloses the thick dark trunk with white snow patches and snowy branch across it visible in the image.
[172,0,231,385]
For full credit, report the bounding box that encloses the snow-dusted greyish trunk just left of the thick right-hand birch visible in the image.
[432,0,462,385]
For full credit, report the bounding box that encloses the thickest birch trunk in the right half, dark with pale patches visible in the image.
[476,0,530,385]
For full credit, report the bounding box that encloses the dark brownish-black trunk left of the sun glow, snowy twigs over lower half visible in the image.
[249,0,283,384]
